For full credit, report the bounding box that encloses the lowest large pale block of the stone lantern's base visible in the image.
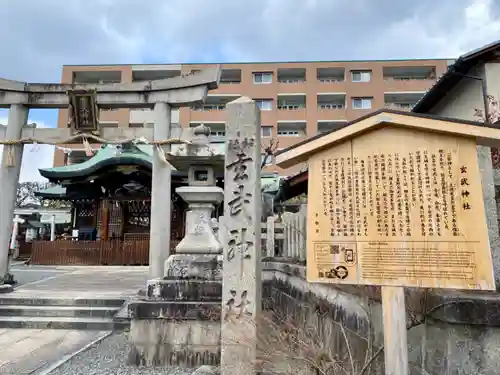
[127,319,221,368]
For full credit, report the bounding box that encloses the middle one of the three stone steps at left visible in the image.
[0,305,120,318]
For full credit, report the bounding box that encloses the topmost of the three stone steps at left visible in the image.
[0,296,125,308]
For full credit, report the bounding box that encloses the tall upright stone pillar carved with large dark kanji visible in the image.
[219,97,262,375]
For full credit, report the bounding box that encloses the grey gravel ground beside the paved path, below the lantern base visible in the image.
[50,332,193,375]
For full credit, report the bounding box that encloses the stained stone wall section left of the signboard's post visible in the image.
[261,261,383,375]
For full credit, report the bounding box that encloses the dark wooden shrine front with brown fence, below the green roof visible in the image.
[31,195,185,265]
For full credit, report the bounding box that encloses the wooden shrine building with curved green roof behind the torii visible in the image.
[31,145,186,265]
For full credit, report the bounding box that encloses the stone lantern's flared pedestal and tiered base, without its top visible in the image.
[129,186,223,367]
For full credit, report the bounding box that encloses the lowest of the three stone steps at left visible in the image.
[0,316,129,331]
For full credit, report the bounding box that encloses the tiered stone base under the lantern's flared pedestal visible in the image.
[128,254,222,368]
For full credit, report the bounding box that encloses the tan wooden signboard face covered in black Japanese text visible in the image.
[307,127,495,290]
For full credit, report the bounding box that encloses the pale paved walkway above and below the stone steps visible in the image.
[0,265,148,375]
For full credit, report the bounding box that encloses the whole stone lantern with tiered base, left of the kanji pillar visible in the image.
[135,125,225,367]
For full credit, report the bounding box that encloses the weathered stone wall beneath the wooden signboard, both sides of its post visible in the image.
[263,259,500,375]
